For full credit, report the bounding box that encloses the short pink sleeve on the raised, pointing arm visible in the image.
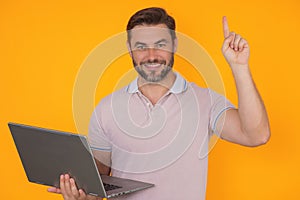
[209,90,235,134]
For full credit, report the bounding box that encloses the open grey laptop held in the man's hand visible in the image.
[8,122,154,198]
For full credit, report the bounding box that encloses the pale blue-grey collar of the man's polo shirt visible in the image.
[126,72,187,94]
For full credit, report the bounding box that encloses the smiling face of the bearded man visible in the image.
[128,24,176,82]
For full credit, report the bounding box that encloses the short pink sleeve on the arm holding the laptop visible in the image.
[88,106,112,152]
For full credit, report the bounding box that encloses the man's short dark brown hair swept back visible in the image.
[126,7,176,41]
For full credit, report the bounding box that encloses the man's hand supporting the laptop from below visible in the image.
[48,174,101,200]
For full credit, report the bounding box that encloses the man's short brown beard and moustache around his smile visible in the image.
[132,54,174,83]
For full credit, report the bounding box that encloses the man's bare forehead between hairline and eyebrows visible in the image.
[130,24,172,43]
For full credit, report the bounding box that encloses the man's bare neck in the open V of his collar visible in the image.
[138,71,176,105]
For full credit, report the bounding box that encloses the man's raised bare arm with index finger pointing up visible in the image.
[217,17,270,146]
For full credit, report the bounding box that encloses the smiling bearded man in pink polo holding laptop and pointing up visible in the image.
[49,8,270,200]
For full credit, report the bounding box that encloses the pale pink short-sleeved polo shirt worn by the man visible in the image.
[89,74,234,200]
